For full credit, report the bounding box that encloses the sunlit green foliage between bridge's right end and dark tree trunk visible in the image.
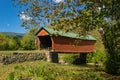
[87,28,107,64]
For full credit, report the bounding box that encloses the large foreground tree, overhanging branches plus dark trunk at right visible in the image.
[15,0,120,74]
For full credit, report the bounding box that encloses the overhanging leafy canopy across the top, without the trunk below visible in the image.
[14,0,120,30]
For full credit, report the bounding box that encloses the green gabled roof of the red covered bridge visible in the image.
[37,27,96,40]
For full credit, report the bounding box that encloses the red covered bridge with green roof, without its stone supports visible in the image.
[37,27,96,63]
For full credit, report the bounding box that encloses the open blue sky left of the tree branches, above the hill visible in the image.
[0,0,26,33]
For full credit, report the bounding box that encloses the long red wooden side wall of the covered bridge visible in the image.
[52,36,95,53]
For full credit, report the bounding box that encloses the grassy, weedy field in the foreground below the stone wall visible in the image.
[0,61,120,80]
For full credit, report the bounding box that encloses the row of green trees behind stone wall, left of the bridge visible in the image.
[0,28,37,50]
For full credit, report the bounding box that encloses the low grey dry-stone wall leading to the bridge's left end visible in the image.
[0,52,46,65]
